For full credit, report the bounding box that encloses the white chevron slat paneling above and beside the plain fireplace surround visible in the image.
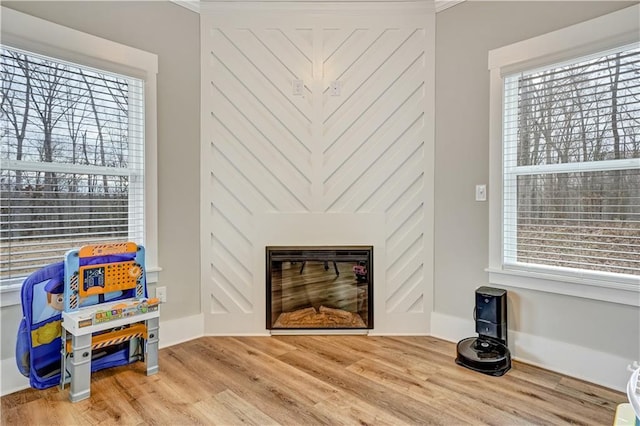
[202,9,432,332]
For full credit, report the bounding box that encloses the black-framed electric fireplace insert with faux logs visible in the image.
[266,246,373,330]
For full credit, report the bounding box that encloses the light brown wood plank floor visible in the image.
[2,335,626,425]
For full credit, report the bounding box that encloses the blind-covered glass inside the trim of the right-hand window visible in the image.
[503,44,640,276]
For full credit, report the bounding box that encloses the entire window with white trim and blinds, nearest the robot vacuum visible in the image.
[489,6,640,304]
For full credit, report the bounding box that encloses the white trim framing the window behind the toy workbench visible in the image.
[0,6,161,307]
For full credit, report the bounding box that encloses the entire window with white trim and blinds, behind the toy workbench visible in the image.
[0,8,158,305]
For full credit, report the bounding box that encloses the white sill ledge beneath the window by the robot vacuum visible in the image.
[486,267,640,307]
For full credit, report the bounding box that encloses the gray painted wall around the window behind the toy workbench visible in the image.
[0,1,200,360]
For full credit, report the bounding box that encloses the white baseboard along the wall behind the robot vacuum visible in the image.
[431,312,633,392]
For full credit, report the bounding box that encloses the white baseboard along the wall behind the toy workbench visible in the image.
[0,314,204,396]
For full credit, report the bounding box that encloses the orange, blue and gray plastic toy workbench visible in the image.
[60,242,160,402]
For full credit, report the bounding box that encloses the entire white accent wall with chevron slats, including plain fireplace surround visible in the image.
[201,3,435,335]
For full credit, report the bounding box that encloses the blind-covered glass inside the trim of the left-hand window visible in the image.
[0,46,144,285]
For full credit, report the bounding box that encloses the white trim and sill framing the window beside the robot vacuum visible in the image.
[486,5,640,306]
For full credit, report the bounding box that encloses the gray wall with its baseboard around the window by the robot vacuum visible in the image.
[432,1,640,388]
